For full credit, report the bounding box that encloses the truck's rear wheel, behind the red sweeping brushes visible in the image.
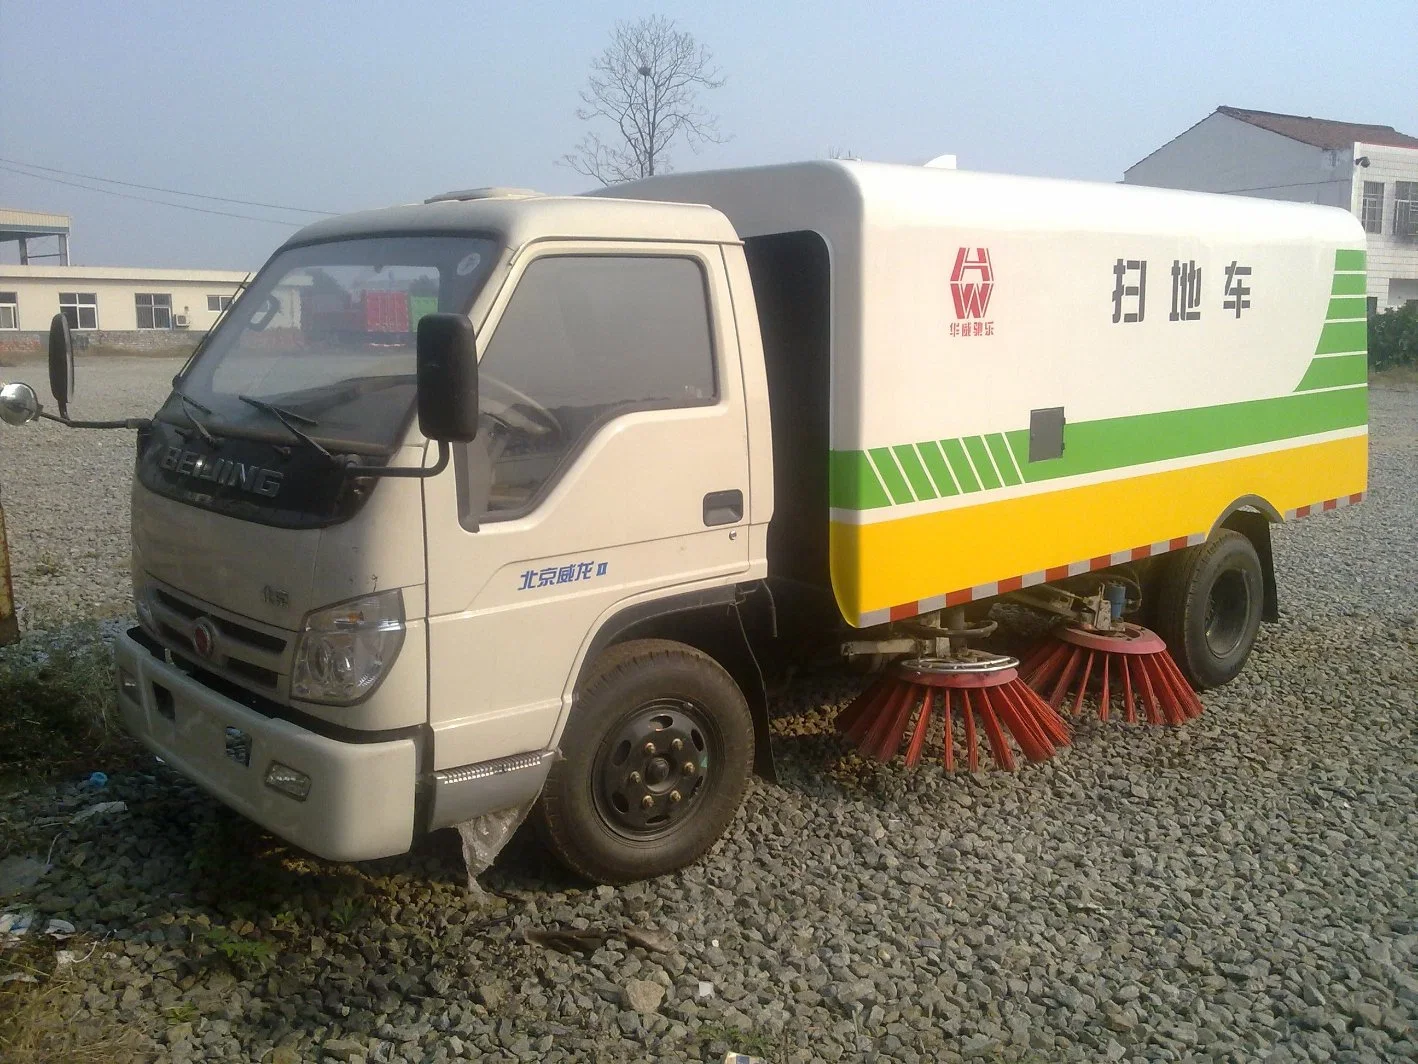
[1149,528,1265,691]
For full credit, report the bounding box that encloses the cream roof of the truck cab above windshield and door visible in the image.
[284,190,739,248]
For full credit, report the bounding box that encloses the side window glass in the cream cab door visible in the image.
[475,255,718,521]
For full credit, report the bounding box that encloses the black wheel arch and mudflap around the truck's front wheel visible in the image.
[571,580,777,783]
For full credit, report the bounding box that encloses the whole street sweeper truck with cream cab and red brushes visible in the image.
[0,162,1367,882]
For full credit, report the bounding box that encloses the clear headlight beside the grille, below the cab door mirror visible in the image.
[291,587,404,705]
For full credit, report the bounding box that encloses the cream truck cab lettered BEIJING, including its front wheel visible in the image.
[118,190,773,880]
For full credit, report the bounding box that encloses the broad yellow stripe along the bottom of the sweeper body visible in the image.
[830,434,1368,623]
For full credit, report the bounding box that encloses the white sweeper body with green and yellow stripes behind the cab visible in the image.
[600,162,1367,626]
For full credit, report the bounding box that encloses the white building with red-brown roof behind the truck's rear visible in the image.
[1123,106,1418,314]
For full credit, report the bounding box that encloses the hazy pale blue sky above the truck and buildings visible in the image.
[0,0,1418,270]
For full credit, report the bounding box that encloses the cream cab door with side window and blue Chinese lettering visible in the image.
[425,241,749,769]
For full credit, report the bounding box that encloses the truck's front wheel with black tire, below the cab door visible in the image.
[532,640,753,884]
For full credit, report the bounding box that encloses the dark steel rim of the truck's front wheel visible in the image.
[591,698,723,841]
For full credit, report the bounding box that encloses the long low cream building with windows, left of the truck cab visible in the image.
[0,264,247,342]
